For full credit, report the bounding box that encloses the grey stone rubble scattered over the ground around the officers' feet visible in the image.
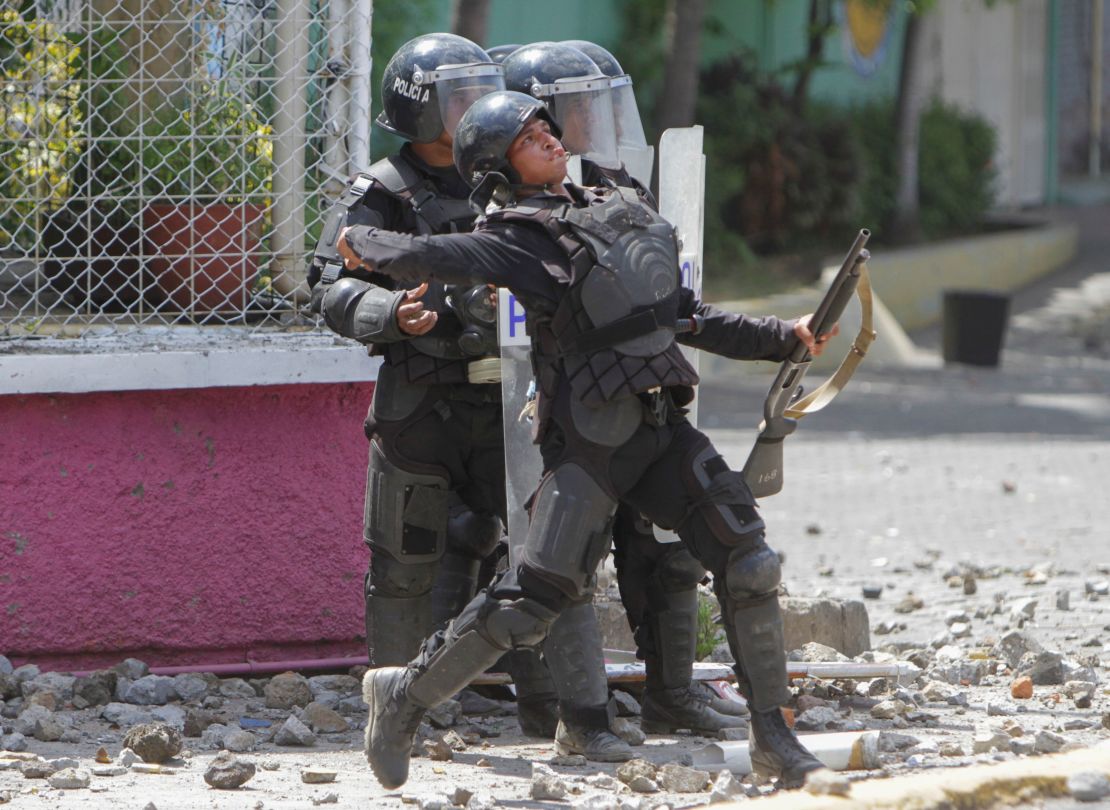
[0,554,1110,810]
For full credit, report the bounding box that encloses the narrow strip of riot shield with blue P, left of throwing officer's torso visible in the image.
[497,287,543,565]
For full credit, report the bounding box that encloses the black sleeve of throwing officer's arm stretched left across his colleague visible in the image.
[346,217,569,304]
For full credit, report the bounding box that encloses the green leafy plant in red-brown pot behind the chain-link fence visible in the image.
[141,74,272,321]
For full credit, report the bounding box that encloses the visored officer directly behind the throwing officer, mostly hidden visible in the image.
[502,40,743,733]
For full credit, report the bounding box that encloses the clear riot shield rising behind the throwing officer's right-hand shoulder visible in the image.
[655,126,705,543]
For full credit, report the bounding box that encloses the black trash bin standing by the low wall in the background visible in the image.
[944,290,1010,366]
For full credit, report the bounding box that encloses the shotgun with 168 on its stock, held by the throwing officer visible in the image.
[744,229,871,498]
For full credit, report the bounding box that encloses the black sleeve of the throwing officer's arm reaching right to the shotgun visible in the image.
[678,287,798,361]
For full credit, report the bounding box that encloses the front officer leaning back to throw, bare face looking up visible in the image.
[339,91,821,788]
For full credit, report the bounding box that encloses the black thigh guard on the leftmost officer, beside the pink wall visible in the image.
[363,439,451,563]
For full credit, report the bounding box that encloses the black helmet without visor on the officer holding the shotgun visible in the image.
[453,90,559,188]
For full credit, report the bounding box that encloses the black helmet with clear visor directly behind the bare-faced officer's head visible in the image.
[502,42,620,169]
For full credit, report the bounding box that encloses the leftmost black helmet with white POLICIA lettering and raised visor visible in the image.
[376,33,505,143]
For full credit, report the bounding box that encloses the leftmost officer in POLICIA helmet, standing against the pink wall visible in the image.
[309,33,556,738]
